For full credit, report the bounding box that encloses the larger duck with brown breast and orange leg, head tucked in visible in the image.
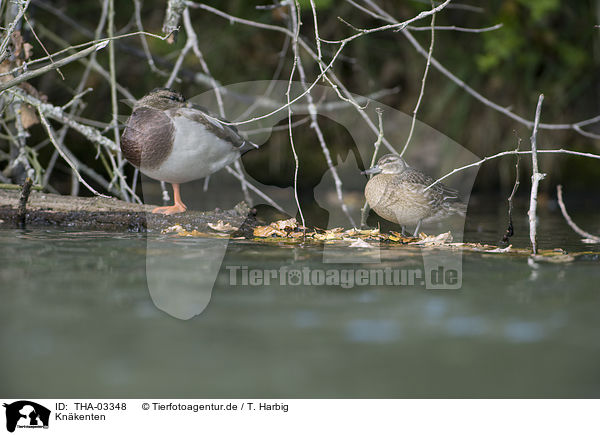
[121,88,258,214]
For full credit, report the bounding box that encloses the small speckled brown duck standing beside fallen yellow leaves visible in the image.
[362,154,466,237]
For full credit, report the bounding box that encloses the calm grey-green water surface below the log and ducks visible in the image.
[0,206,600,398]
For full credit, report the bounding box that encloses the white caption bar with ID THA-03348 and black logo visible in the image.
[0,399,600,435]
